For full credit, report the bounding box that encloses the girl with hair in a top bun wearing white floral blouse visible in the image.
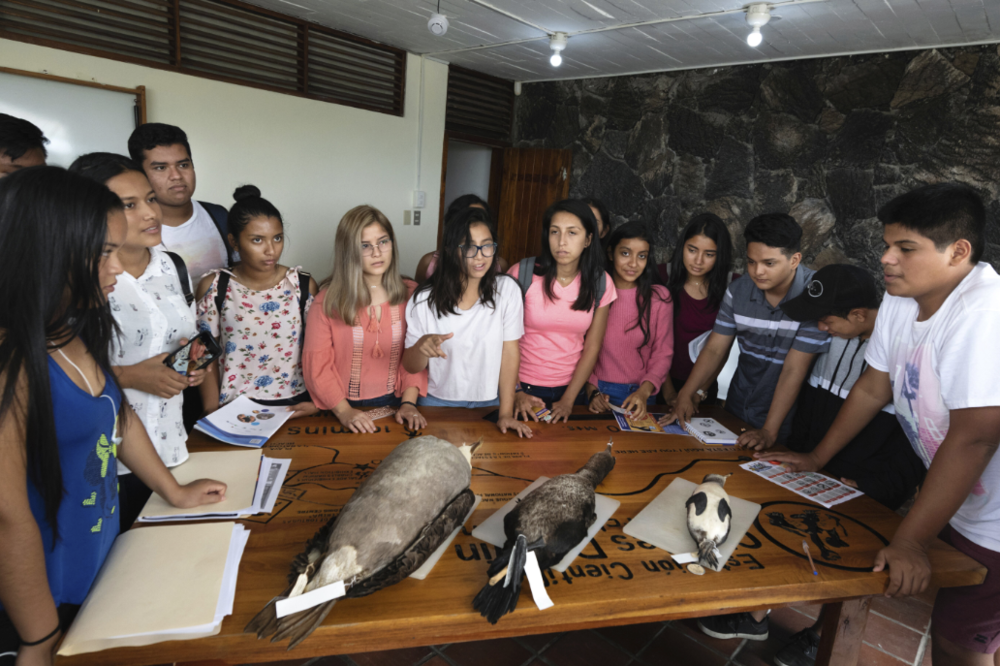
[198,185,318,418]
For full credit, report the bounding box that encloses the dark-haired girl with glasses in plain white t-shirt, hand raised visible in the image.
[403,208,531,437]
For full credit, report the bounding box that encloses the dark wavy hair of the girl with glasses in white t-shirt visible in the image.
[418,208,503,317]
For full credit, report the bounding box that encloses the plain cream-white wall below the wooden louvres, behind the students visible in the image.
[0,39,448,279]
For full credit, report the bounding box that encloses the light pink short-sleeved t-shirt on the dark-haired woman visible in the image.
[507,263,617,386]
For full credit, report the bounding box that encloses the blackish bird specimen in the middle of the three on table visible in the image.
[472,442,615,624]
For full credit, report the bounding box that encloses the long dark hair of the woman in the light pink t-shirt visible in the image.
[535,199,607,312]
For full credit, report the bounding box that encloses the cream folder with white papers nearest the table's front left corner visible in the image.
[59,523,250,657]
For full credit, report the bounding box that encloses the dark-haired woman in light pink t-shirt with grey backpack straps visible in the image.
[510,199,615,423]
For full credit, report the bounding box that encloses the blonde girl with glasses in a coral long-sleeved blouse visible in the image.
[302,206,427,433]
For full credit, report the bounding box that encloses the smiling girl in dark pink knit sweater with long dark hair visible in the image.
[584,222,674,419]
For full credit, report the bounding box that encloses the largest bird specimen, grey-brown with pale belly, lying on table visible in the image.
[243,437,482,650]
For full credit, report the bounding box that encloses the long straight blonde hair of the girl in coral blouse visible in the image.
[322,206,409,326]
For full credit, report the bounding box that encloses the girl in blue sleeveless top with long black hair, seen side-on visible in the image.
[0,167,226,664]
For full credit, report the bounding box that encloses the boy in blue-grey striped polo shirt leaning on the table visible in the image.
[667,213,830,450]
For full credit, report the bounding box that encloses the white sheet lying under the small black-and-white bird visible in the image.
[622,479,760,571]
